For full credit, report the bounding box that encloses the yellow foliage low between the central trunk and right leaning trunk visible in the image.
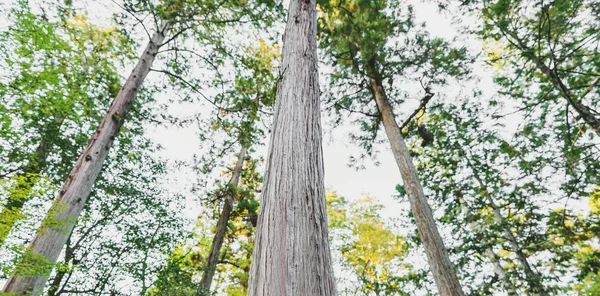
[327,192,422,295]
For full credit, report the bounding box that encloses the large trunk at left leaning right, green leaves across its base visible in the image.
[3,24,168,295]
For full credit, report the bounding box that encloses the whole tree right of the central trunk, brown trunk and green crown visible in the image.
[321,0,463,296]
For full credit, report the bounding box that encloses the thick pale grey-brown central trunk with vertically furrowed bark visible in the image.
[248,0,336,296]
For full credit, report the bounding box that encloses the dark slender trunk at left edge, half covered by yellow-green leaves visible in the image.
[0,118,64,246]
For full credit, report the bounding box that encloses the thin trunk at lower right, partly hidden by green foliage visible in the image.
[467,158,545,295]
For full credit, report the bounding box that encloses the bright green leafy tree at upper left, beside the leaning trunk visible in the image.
[0,5,126,246]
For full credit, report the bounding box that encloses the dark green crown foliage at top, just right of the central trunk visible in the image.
[318,0,468,165]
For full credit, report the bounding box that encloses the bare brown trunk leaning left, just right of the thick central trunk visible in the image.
[370,75,464,296]
